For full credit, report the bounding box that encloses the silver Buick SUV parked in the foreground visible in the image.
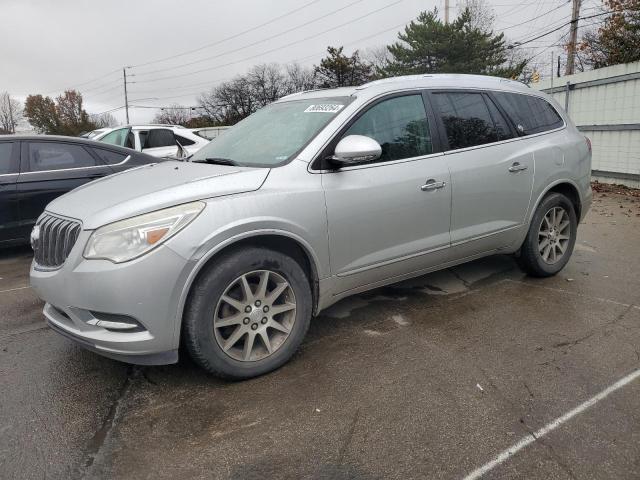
[31,75,591,378]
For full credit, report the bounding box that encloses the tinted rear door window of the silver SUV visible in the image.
[433,92,509,150]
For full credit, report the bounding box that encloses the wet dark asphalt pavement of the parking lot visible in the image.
[0,189,640,479]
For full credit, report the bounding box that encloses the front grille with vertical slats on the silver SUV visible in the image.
[31,213,82,268]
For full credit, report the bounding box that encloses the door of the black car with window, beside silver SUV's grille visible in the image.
[17,140,113,235]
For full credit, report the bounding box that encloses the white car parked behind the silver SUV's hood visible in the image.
[94,125,209,158]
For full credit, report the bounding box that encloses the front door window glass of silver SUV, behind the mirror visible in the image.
[343,95,433,161]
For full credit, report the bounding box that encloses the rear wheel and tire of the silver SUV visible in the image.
[519,193,578,277]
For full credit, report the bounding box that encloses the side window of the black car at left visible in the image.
[28,142,96,172]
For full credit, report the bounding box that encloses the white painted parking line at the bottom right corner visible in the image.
[464,369,640,480]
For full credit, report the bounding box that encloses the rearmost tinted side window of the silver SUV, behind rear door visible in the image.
[493,92,563,134]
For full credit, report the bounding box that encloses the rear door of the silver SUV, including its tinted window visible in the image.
[431,90,534,256]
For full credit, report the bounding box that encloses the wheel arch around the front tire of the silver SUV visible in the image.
[176,230,319,344]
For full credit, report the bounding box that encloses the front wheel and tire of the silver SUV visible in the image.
[182,247,312,380]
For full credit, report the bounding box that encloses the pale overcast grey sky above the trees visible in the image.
[0,0,601,123]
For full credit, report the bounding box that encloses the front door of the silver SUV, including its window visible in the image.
[322,93,451,294]
